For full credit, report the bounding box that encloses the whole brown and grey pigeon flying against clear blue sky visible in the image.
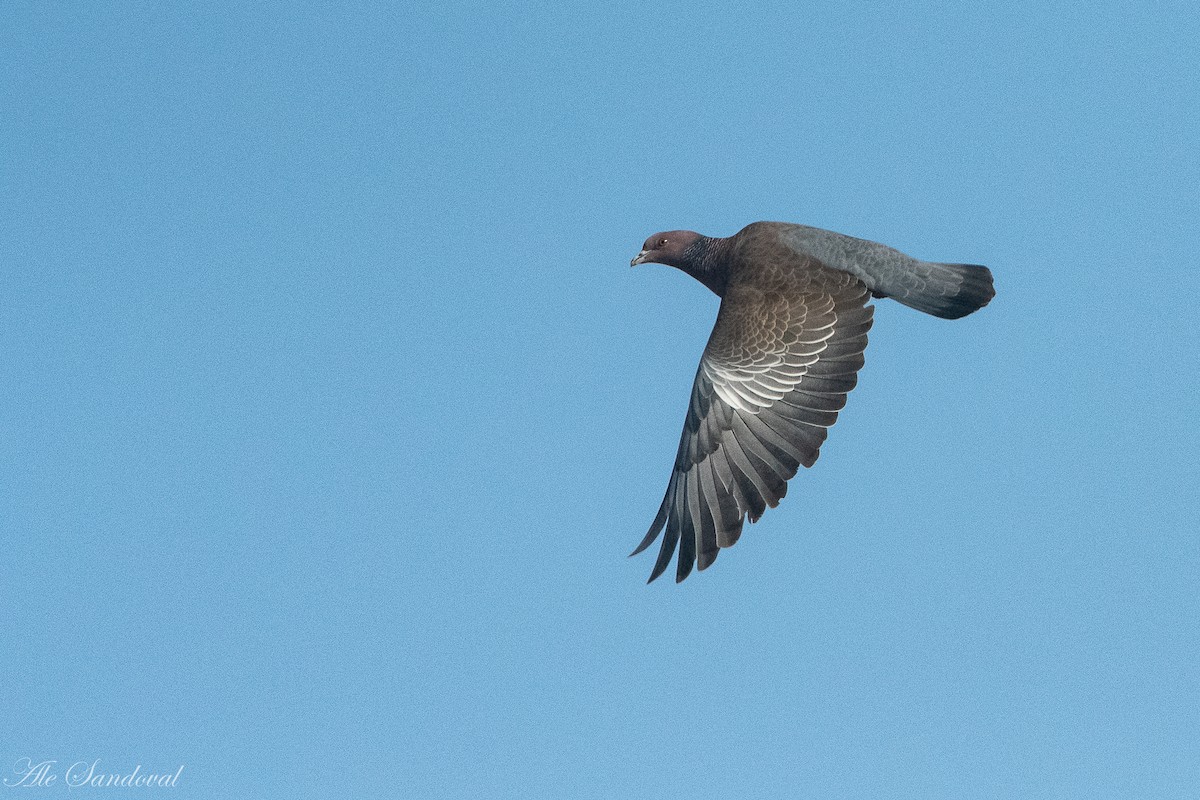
[630,222,996,583]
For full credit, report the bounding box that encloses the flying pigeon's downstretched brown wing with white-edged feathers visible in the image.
[634,266,874,582]
